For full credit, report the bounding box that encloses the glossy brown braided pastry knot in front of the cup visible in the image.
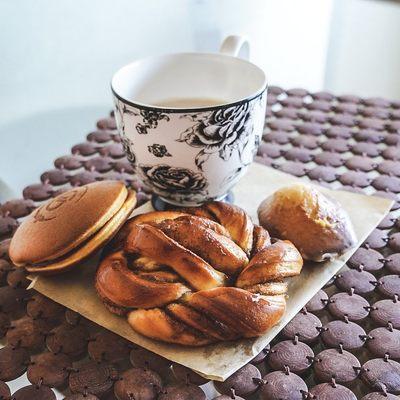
[95,202,303,346]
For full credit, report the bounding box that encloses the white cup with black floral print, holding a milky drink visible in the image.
[111,36,267,206]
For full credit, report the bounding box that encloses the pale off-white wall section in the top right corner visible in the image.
[325,0,400,99]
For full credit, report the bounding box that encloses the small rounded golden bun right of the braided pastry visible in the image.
[258,184,356,261]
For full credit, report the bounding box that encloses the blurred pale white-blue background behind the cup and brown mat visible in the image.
[0,0,400,201]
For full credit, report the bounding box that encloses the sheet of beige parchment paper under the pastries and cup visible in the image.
[31,164,392,380]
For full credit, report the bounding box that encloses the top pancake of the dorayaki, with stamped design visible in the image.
[10,181,128,266]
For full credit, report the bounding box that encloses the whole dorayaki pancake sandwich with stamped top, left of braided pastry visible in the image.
[9,181,136,274]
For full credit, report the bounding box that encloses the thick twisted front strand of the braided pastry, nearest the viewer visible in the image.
[128,287,286,346]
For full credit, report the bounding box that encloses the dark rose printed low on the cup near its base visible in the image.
[139,164,207,198]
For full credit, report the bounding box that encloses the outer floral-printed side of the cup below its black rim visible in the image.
[115,92,265,205]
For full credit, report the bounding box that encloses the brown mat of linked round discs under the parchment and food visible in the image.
[0,87,400,400]
